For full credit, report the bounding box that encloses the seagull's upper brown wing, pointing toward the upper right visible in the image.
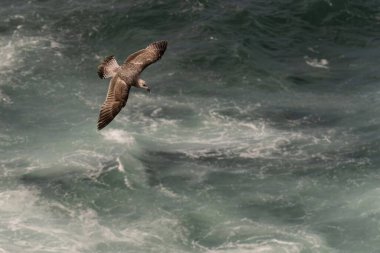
[124,40,168,72]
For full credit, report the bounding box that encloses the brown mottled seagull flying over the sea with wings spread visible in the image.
[98,40,168,130]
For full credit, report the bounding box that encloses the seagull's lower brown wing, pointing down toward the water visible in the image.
[98,77,131,130]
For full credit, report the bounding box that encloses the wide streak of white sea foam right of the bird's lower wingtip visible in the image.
[116,95,331,160]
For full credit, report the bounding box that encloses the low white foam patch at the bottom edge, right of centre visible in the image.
[193,219,334,253]
